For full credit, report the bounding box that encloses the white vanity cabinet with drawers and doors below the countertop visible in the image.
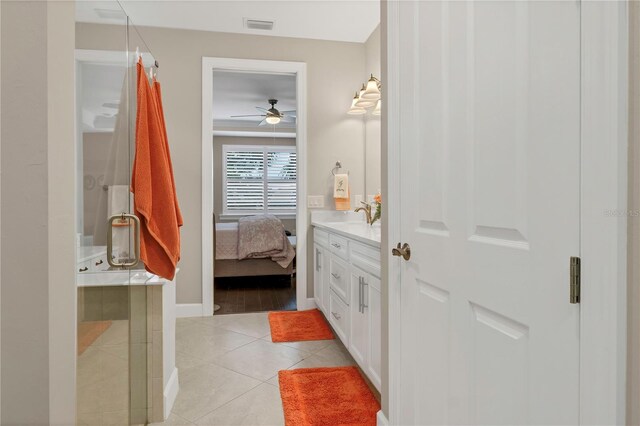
[314,224,382,390]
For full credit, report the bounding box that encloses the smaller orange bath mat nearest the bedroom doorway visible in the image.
[269,309,334,342]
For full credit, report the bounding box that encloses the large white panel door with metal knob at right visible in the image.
[389,1,580,425]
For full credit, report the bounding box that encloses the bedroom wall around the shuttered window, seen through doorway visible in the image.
[213,136,296,235]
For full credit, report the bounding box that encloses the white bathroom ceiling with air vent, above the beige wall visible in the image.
[76,0,380,43]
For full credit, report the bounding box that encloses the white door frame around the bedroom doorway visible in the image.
[202,57,313,316]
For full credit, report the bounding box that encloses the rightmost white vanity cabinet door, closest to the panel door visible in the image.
[364,276,382,390]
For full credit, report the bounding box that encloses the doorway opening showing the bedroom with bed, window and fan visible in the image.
[203,61,306,315]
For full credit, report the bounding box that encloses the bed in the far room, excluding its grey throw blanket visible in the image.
[213,214,296,278]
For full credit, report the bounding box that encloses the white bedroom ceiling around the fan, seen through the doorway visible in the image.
[213,71,296,129]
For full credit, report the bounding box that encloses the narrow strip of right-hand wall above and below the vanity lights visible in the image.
[364,26,384,196]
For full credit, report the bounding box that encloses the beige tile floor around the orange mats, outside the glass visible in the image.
[154,312,362,425]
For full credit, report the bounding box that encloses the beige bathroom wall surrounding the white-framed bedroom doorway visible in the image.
[76,24,367,303]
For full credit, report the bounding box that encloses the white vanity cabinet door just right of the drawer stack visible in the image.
[349,265,369,369]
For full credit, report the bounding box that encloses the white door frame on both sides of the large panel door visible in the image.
[382,1,628,424]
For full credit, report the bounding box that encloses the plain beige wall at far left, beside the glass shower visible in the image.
[0,1,76,424]
